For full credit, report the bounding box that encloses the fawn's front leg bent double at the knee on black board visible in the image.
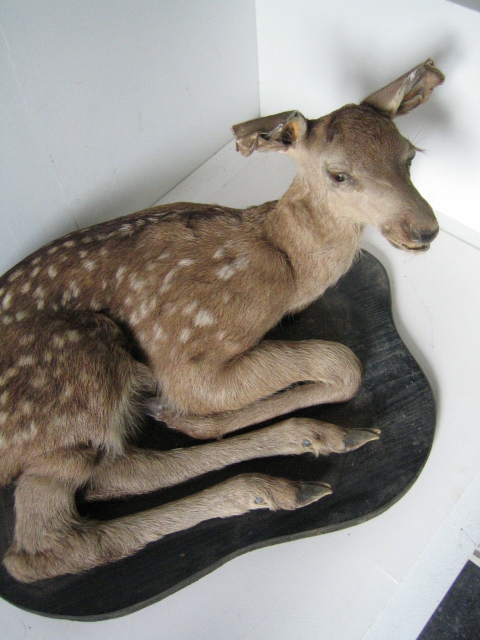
[147,340,361,439]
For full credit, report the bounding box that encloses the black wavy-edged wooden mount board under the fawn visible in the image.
[0,252,435,620]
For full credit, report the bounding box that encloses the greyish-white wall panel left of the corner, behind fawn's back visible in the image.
[0,0,259,273]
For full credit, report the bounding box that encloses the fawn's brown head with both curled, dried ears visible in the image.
[233,60,444,251]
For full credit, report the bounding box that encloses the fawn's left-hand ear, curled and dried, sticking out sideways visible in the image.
[232,111,307,156]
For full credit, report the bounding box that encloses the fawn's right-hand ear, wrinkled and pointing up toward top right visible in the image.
[362,60,445,118]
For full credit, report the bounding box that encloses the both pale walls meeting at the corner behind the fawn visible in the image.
[0,0,480,272]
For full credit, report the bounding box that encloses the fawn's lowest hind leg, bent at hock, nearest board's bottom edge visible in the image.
[3,474,331,582]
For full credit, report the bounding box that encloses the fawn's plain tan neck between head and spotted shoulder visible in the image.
[266,174,363,310]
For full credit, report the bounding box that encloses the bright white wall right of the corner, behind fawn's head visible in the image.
[256,0,480,231]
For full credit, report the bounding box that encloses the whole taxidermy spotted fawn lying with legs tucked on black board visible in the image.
[0,60,444,582]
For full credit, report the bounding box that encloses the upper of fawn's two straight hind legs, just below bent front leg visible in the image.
[85,418,380,500]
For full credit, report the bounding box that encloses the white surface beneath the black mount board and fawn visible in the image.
[0,144,480,640]
